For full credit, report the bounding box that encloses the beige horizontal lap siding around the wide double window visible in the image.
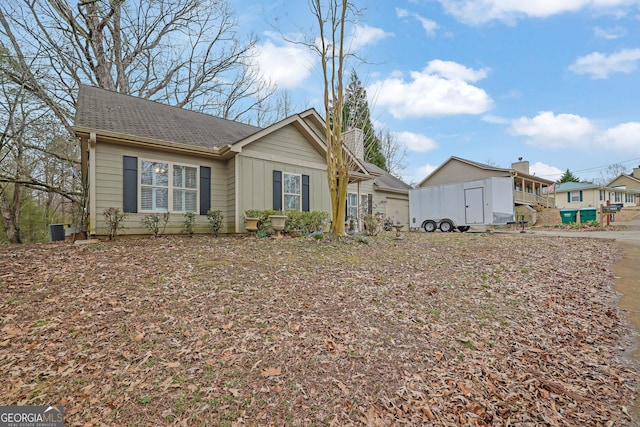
[90,140,228,236]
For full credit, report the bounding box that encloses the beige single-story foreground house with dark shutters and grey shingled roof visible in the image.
[74,85,408,236]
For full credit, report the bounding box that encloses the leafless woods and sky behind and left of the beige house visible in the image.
[0,0,275,243]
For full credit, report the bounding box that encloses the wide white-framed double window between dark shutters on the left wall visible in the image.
[140,159,198,212]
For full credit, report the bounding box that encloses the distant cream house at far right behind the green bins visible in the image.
[553,182,640,209]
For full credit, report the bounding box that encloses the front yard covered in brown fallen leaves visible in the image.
[0,233,638,426]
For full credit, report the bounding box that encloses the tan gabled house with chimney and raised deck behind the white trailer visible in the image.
[417,156,553,207]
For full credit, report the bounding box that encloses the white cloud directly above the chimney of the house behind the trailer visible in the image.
[509,111,596,148]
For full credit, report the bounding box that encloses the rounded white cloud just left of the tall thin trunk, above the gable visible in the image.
[255,40,316,89]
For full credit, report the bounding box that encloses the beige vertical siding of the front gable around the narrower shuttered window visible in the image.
[235,126,331,230]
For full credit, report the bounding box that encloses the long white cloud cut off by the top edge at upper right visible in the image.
[438,0,637,25]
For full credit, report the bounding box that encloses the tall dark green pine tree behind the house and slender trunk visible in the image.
[342,70,386,170]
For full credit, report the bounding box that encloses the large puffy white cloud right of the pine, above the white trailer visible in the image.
[367,60,493,119]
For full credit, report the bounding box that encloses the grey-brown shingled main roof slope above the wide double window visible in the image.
[74,85,261,148]
